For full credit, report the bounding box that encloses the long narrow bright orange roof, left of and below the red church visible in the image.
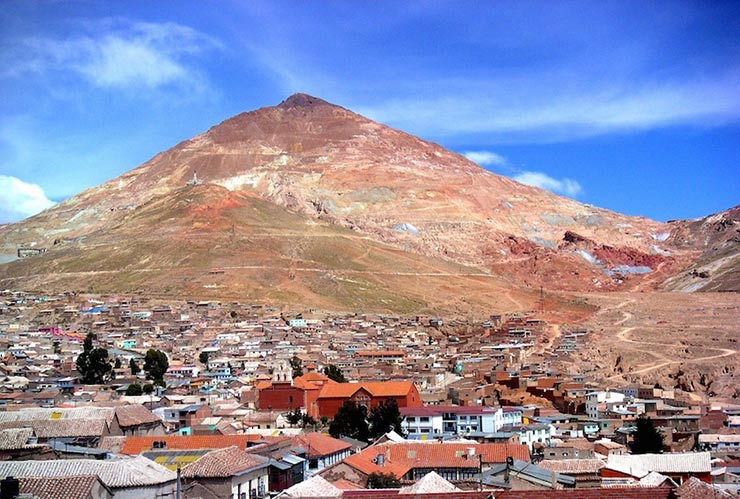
[121,434,288,456]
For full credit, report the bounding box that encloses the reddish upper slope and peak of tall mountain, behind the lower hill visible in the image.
[0,94,728,296]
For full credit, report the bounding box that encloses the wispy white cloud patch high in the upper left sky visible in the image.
[3,19,220,91]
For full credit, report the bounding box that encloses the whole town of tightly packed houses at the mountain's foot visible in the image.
[0,291,740,499]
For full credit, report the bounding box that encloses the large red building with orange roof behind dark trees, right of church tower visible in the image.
[317,381,423,418]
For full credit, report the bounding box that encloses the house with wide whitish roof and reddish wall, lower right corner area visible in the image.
[600,452,712,485]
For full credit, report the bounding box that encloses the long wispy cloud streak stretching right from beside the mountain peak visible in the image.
[361,70,740,140]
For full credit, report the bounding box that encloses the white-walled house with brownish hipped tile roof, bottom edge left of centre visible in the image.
[182,446,270,499]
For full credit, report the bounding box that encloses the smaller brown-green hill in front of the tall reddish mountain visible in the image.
[0,184,588,315]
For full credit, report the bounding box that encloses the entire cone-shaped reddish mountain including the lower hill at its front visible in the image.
[0,94,732,310]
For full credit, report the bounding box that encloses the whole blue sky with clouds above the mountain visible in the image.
[0,0,740,222]
